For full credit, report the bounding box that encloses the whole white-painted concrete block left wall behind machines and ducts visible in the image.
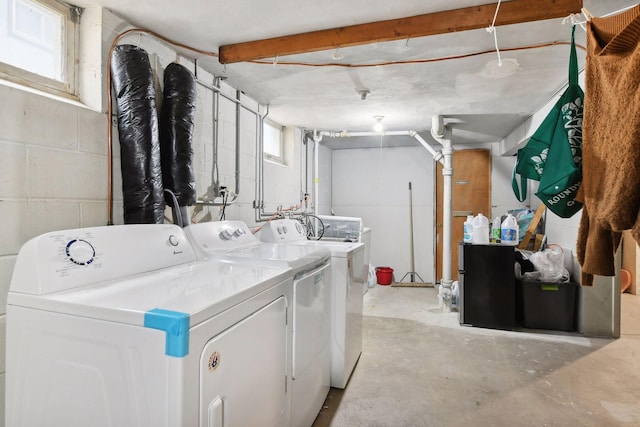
[0,8,301,427]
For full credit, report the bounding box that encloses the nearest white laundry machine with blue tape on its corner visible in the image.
[5,225,291,427]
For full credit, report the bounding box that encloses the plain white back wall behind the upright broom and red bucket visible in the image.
[331,146,434,281]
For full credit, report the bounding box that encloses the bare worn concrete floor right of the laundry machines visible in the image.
[313,285,640,427]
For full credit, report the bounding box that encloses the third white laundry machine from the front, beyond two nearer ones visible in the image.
[260,219,367,388]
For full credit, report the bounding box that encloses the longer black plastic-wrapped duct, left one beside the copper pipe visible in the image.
[110,45,164,224]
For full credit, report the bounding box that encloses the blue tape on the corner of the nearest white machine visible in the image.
[144,308,189,357]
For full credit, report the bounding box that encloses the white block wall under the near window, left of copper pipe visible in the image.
[0,85,107,424]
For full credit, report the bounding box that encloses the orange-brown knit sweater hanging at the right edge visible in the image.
[576,5,640,285]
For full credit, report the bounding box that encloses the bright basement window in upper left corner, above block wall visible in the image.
[0,0,80,99]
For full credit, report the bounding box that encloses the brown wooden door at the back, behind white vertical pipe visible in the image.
[436,149,491,282]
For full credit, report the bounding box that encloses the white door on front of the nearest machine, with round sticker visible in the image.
[200,297,287,427]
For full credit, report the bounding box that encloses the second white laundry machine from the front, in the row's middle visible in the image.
[185,221,331,427]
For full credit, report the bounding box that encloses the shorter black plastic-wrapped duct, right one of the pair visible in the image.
[160,63,196,207]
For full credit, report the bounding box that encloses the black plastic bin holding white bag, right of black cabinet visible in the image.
[516,280,579,332]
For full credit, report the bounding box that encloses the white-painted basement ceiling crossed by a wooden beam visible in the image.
[75,0,638,148]
